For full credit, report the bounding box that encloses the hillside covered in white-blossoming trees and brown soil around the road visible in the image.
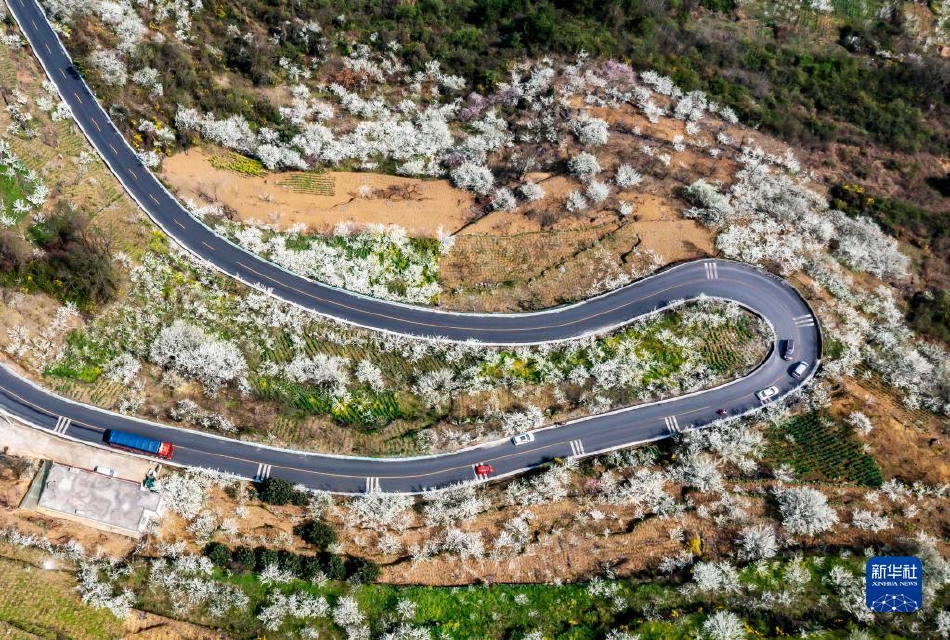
[0,0,950,640]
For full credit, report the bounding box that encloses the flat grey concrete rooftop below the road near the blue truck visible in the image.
[36,463,163,537]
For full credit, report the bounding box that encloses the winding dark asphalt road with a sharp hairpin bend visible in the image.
[0,0,821,493]
